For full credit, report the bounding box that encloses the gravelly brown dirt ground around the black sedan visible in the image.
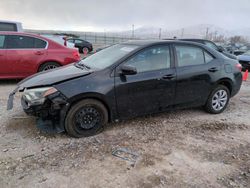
[0,81,250,188]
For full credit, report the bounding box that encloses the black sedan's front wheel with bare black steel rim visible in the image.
[65,99,108,138]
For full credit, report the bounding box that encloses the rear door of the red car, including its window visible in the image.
[6,35,47,77]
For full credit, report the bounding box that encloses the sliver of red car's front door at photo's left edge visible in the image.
[0,35,6,77]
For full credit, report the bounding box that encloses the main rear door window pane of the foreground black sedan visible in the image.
[175,46,205,67]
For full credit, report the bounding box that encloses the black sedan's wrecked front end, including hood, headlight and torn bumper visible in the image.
[7,64,93,133]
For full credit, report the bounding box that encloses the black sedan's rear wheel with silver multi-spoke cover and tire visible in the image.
[205,85,230,114]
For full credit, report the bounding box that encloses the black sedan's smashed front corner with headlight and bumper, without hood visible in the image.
[7,87,69,133]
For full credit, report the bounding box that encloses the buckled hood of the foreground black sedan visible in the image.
[17,64,93,90]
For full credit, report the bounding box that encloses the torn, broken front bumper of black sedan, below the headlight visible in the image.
[7,87,69,133]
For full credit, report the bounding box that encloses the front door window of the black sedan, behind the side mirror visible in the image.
[125,46,170,73]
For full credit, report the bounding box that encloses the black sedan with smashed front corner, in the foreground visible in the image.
[8,40,242,137]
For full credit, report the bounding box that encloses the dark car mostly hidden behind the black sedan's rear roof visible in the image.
[179,39,237,59]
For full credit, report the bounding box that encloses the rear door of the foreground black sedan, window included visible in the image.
[175,44,221,106]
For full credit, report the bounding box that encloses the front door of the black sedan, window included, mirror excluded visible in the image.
[115,45,176,118]
